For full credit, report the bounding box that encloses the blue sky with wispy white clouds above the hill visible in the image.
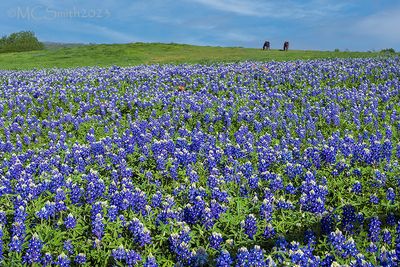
[0,0,400,51]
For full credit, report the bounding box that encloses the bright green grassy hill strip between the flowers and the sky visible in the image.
[0,43,388,69]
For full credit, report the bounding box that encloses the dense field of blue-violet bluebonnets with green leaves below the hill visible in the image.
[0,58,400,266]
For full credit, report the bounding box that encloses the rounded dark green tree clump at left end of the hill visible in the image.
[0,31,44,53]
